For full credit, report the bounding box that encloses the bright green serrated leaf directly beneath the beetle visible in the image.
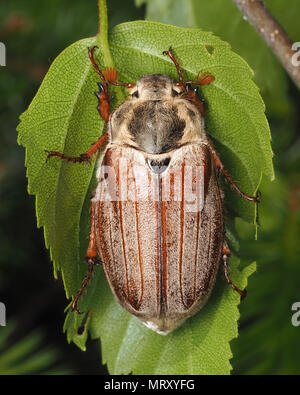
[18,22,273,374]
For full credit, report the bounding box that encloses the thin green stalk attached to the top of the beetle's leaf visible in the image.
[97,0,114,68]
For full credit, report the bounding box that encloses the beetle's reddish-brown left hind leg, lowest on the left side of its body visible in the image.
[71,201,100,313]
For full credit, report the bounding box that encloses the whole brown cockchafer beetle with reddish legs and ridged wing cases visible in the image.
[46,47,259,334]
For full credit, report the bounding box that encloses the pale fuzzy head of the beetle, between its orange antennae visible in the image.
[130,74,182,100]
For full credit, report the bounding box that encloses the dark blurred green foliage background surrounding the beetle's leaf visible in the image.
[0,0,300,374]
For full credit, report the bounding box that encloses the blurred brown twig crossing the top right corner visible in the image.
[232,0,300,89]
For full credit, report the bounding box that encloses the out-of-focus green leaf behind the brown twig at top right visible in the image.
[143,0,300,115]
